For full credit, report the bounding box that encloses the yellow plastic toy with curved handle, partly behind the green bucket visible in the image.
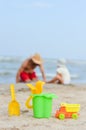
[25,81,45,108]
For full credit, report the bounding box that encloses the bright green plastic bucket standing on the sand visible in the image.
[32,94,57,118]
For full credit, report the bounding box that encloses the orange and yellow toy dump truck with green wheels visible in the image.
[55,103,80,120]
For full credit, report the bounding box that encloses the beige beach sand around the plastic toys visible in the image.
[0,84,86,130]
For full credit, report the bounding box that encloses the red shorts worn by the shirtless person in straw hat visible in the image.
[20,72,37,81]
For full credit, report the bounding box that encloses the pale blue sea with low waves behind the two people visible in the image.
[0,56,86,84]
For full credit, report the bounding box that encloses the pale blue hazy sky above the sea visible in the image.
[0,0,86,60]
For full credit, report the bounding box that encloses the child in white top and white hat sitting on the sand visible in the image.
[47,59,71,84]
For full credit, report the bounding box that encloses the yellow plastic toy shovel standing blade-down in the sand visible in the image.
[8,84,20,116]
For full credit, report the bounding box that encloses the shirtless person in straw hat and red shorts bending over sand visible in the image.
[16,54,46,83]
